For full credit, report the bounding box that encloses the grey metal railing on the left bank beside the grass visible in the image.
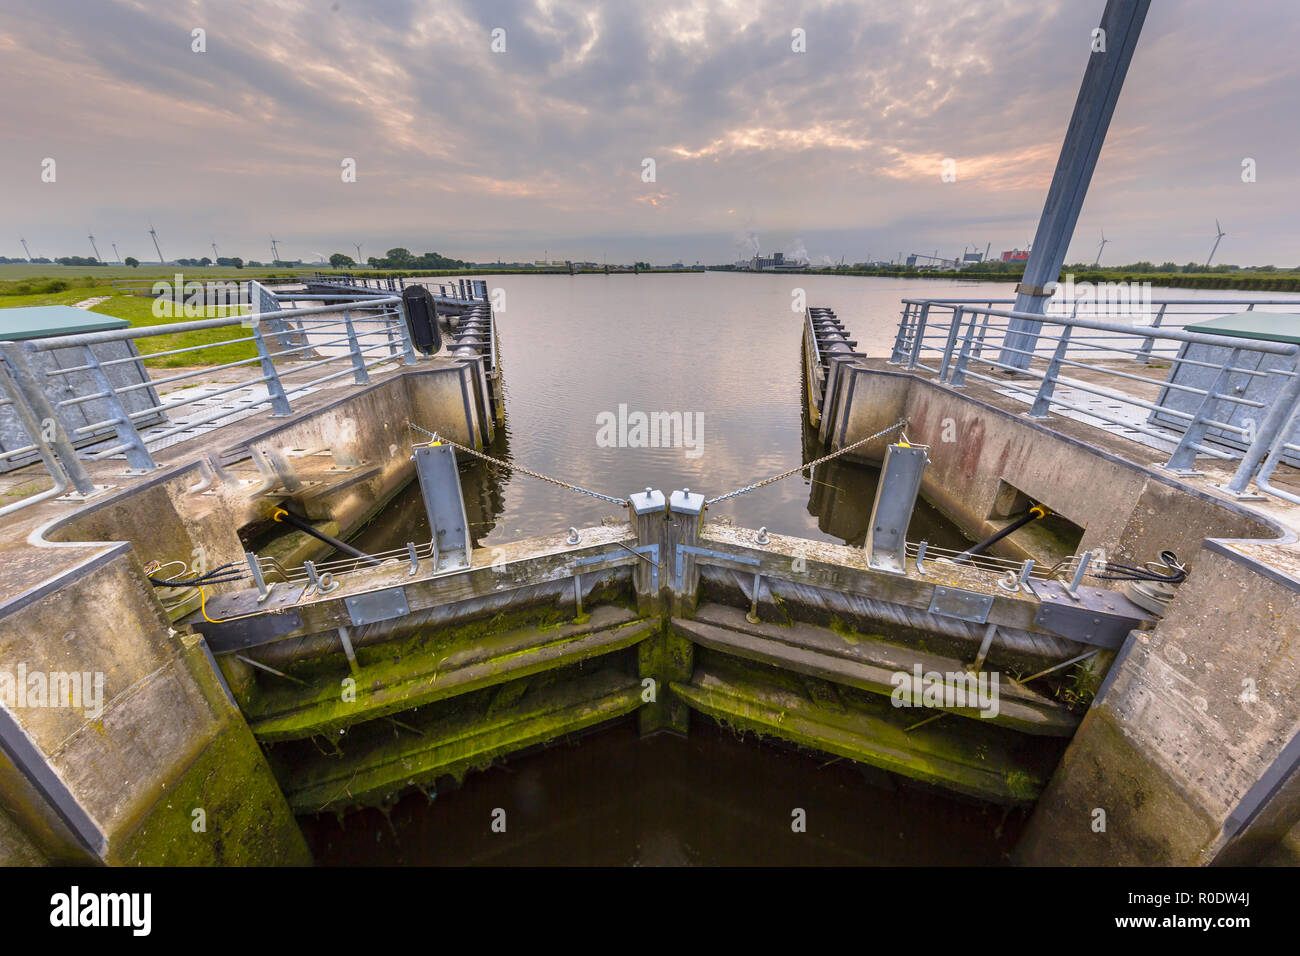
[0,297,416,515]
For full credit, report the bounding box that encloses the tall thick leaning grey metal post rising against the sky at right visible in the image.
[1001,0,1151,368]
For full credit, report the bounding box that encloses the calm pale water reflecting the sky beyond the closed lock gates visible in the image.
[359,273,1011,549]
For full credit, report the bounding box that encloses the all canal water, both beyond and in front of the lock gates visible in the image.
[312,273,1024,865]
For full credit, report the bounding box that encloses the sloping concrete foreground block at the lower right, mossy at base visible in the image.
[1018,550,1300,865]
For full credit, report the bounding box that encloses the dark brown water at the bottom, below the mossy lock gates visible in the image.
[302,718,1026,866]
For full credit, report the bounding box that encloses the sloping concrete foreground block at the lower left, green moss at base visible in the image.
[0,550,306,864]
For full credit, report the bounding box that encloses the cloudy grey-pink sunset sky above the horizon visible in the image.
[0,0,1300,265]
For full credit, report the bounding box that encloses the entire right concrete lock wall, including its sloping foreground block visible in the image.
[823,365,1300,865]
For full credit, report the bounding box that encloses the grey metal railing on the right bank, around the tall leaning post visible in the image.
[889,299,1300,501]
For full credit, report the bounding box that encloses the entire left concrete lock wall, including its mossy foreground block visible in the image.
[0,363,484,864]
